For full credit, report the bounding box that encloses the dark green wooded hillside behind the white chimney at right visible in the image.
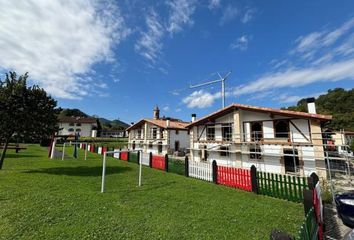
[285,88,354,131]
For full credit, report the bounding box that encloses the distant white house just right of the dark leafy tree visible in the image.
[58,117,97,137]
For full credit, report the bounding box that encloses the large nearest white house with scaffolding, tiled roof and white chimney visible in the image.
[187,99,332,177]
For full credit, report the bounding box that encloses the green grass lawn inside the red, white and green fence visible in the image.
[0,145,303,240]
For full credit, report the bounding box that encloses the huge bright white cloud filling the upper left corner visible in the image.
[0,0,130,99]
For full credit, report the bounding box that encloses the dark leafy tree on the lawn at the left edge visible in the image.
[0,72,59,169]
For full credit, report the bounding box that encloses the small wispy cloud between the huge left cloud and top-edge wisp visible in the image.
[135,9,165,62]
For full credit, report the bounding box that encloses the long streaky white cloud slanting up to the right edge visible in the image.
[228,18,354,102]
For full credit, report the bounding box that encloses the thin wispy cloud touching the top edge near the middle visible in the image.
[167,0,195,34]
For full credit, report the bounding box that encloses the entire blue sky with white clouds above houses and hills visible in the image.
[0,0,354,122]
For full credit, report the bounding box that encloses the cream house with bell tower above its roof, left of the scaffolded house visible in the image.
[127,106,189,154]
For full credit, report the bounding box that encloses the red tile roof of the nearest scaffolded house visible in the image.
[187,104,332,127]
